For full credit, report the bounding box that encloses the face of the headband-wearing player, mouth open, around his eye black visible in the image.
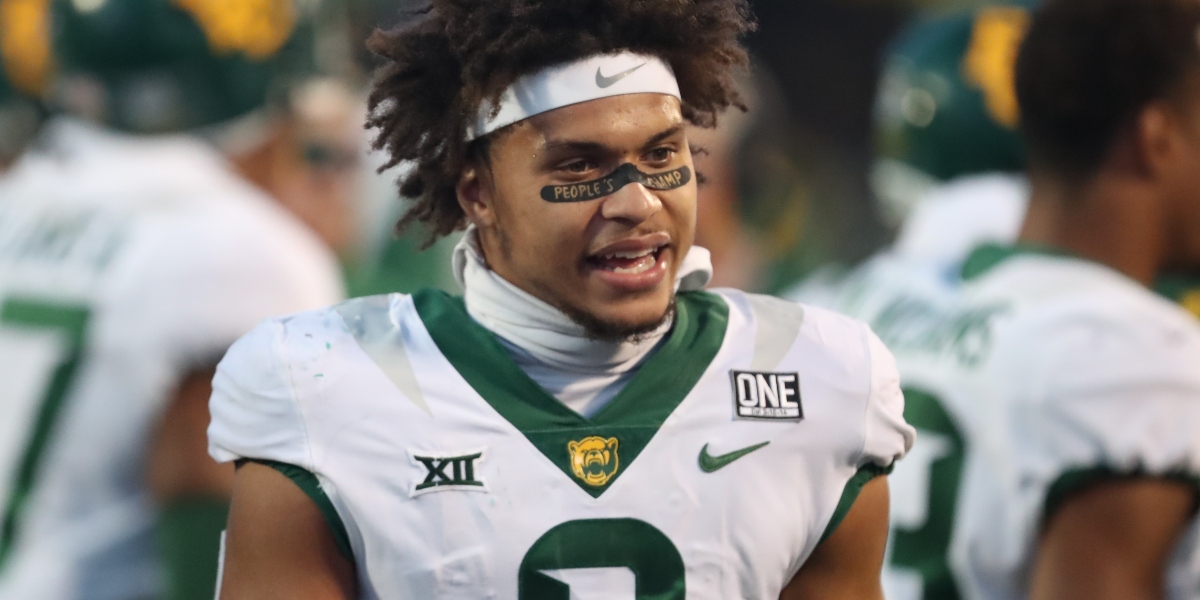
[458,94,696,338]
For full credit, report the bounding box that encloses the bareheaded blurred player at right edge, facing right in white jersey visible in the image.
[820,0,1200,600]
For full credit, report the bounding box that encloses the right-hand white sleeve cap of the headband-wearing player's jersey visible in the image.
[859,326,917,467]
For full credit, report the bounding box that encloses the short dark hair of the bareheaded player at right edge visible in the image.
[1016,0,1200,180]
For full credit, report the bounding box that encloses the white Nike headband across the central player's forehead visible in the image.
[467,52,683,142]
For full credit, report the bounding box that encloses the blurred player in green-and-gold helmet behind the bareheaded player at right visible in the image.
[785,4,1030,316]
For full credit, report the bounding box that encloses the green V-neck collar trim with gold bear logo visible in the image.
[413,290,728,498]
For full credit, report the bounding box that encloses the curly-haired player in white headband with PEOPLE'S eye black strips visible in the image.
[209,0,912,600]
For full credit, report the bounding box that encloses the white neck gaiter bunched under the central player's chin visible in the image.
[454,227,713,376]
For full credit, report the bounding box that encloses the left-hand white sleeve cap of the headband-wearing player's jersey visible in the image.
[209,319,314,470]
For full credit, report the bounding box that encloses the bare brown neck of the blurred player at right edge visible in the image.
[1020,172,1164,284]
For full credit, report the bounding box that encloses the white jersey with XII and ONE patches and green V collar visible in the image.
[209,290,913,600]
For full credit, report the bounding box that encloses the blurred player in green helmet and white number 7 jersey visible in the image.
[0,0,350,600]
